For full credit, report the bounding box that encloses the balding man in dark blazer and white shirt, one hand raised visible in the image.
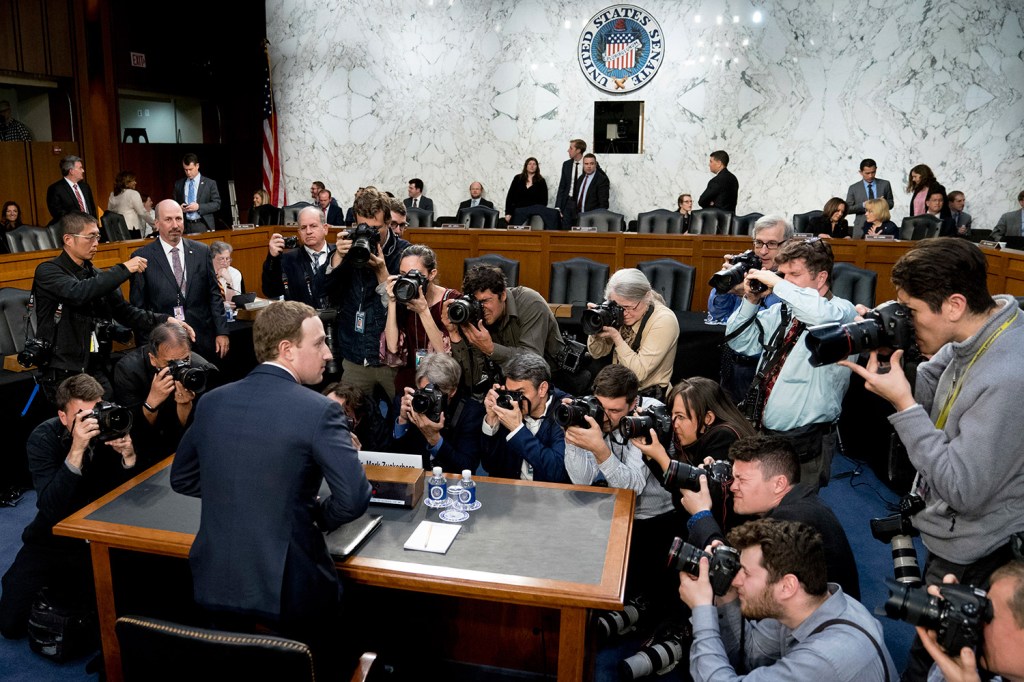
[263,206,337,308]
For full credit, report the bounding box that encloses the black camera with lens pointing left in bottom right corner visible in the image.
[885,579,992,656]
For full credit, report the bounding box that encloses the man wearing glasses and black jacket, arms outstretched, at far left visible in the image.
[32,211,195,402]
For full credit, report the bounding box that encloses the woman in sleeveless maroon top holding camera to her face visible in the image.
[381,244,462,395]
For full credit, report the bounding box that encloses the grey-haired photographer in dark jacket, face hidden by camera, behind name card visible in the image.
[392,353,483,473]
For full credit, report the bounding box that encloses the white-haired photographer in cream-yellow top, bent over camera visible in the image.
[587,267,679,398]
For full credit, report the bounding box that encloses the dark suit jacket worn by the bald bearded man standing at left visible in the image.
[129,238,227,357]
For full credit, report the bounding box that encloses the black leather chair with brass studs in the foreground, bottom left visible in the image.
[115,615,376,682]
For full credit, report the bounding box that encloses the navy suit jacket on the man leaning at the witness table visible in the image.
[171,365,370,621]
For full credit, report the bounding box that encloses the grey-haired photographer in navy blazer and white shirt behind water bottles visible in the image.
[483,353,569,483]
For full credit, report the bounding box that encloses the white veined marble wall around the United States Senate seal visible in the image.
[266,0,1024,227]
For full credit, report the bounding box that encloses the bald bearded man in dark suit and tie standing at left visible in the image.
[130,199,228,358]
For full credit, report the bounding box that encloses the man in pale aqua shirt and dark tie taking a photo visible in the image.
[726,238,857,489]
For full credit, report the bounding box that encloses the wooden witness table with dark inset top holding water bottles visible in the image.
[53,457,635,682]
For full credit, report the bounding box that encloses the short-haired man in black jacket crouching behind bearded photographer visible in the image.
[683,436,860,599]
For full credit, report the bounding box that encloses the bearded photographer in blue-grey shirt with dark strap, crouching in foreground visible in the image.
[679,519,896,682]
